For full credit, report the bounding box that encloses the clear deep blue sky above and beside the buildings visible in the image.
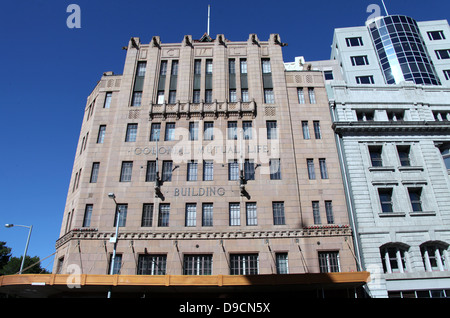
[0,0,450,270]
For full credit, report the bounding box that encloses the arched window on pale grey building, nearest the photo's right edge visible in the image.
[420,241,450,272]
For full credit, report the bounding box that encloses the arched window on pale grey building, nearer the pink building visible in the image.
[380,243,409,273]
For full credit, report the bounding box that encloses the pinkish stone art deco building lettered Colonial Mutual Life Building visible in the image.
[45,34,367,296]
